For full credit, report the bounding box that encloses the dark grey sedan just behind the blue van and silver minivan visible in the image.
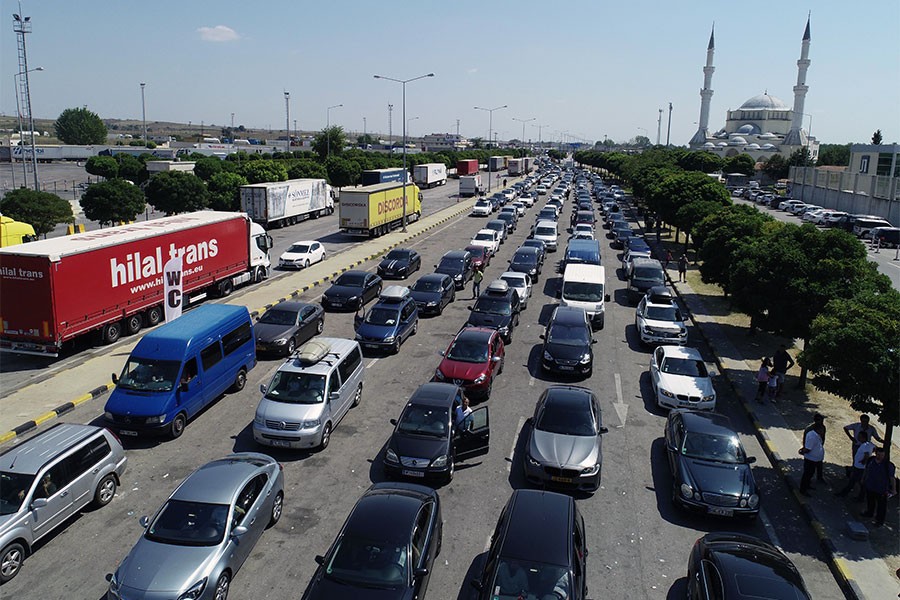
[253,300,325,356]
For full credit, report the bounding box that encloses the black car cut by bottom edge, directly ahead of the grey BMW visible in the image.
[472,489,588,600]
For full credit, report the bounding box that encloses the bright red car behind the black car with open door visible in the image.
[433,327,506,399]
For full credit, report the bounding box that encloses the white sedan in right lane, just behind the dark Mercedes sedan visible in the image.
[650,346,716,410]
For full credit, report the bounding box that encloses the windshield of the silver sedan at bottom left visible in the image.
[144,500,228,546]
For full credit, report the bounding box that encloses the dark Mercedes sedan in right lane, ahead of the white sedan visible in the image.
[665,409,759,519]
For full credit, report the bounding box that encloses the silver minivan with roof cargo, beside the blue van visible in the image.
[253,337,365,450]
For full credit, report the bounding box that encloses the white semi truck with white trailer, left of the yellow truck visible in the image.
[240,179,334,229]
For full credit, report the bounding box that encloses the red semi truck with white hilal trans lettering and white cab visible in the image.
[0,211,272,356]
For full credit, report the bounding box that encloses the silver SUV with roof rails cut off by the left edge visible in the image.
[0,423,127,583]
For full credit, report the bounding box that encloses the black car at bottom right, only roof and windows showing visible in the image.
[687,532,810,600]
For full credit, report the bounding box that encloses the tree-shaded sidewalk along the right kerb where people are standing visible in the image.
[670,265,900,600]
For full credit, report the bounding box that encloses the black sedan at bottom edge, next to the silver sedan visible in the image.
[303,483,443,600]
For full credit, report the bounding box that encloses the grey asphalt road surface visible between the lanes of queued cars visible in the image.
[2,180,843,599]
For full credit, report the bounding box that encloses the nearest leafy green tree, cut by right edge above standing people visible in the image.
[799,289,900,452]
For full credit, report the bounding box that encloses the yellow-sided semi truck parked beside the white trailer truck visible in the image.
[338,182,422,237]
